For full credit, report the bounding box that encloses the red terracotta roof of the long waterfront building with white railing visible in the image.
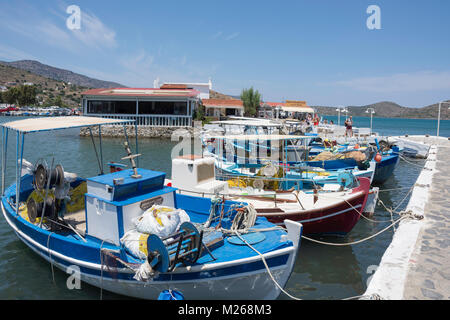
[81,88,200,97]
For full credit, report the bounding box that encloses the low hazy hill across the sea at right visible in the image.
[312,101,450,120]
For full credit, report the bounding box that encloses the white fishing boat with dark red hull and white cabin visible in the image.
[165,155,370,236]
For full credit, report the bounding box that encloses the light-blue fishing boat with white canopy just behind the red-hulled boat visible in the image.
[203,134,376,190]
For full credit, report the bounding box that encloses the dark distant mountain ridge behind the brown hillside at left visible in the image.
[0,60,125,88]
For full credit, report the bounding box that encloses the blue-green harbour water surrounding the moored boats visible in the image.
[0,117,442,299]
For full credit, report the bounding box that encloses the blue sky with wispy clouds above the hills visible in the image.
[0,0,450,107]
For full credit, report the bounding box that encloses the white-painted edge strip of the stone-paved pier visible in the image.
[364,136,438,300]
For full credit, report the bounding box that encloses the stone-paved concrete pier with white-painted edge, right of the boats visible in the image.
[364,136,450,300]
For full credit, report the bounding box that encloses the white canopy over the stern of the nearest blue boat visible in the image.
[2,116,134,133]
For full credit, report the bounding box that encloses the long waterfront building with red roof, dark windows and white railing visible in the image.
[81,85,200,127]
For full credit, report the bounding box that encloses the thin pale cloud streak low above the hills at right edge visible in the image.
[333,71,450,93]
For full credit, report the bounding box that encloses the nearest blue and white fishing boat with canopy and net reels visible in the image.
[1,116,302,299]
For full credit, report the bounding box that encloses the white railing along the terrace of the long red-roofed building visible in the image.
[86,113,192,127]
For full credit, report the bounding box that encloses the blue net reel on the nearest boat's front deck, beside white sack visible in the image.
[147,222,203,272]
